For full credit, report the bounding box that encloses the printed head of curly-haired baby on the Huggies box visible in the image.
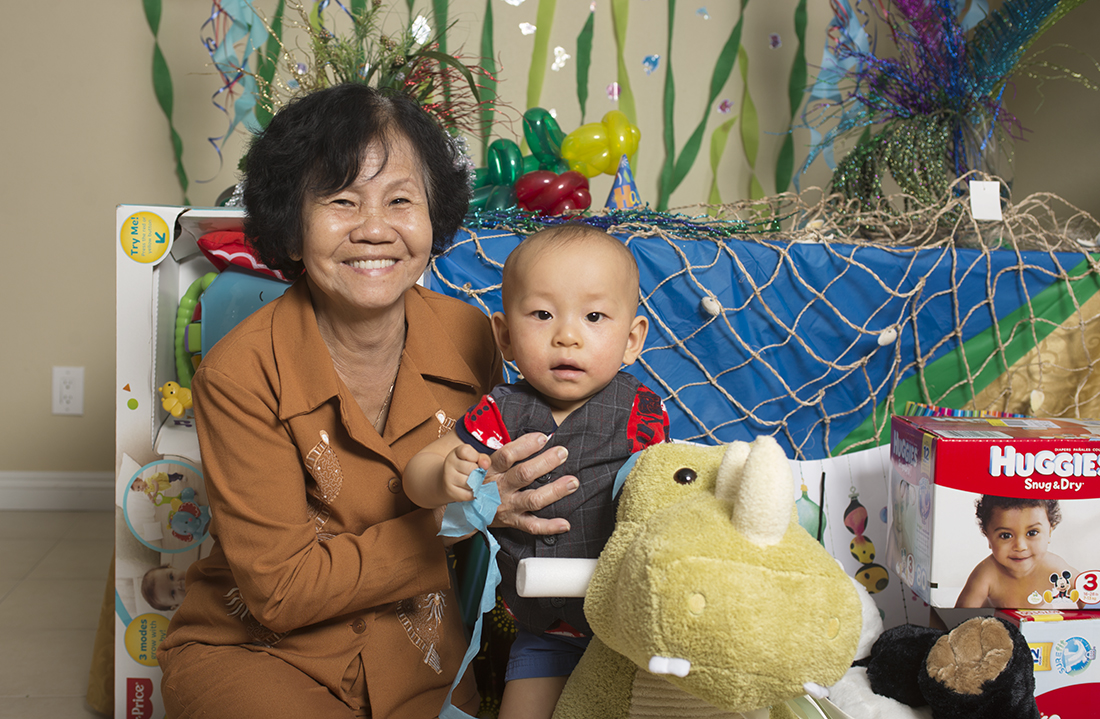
[976,495,1062,576]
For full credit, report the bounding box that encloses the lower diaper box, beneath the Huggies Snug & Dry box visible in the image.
[997,609,1100,719]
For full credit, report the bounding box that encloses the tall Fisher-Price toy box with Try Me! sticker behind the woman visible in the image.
[114,206,286,719]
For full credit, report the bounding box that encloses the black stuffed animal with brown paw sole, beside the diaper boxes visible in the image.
[854,617,1040,719]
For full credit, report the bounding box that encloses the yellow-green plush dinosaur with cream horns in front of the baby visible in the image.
[553,438,862,719]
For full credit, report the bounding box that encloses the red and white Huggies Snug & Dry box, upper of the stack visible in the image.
[886,416,1100,609]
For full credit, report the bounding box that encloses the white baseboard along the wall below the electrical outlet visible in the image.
[0,472,114,511]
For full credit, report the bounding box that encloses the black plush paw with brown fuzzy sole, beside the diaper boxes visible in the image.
[919,617,1040,719]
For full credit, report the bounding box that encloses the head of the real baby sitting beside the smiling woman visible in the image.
[493,223,649,411]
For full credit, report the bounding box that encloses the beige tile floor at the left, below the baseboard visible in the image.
[0,511,114,719]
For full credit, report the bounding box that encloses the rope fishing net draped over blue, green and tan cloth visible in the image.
[430,175,1100,460]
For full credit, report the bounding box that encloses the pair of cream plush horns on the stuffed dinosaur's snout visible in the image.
[715,436,794,546]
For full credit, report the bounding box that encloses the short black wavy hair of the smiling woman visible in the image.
[244,82,470,279]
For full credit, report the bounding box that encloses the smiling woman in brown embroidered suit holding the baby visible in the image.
[157,85,576,719]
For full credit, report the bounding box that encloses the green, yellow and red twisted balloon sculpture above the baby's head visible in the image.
[470,108,640,214]
